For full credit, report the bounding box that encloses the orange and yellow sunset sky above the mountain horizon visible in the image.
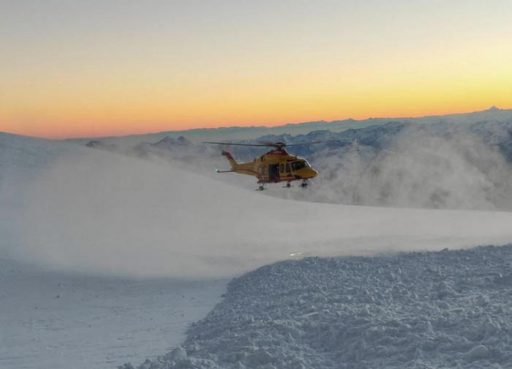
[0,0,512,138]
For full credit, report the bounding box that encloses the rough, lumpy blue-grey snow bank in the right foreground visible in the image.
[124,245,512,369]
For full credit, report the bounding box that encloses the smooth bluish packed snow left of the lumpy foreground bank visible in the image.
[0,259,226,369]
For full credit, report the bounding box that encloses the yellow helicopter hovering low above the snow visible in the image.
[205,142,320,191]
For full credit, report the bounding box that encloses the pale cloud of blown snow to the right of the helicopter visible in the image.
[304,125,512,210]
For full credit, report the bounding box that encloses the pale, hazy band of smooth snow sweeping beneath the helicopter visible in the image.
[5,136,512,278]
